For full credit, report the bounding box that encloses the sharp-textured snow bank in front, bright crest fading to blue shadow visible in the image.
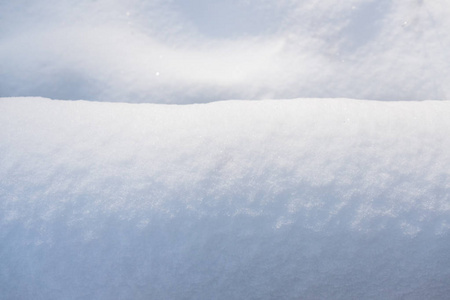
[0,98,450,299]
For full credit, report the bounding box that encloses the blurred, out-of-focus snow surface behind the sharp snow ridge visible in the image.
[0,0,450,103]
